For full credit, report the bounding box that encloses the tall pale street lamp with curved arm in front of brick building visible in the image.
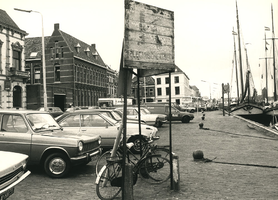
[14,8,47,111]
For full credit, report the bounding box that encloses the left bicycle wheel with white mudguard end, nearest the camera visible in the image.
[96,163,122,200]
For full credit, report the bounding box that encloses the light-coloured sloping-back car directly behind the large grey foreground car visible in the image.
[57,110,159,153]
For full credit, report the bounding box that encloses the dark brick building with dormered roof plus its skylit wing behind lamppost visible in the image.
[26,24,109,110]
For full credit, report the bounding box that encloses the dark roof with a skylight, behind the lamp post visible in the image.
[25,36,50,59]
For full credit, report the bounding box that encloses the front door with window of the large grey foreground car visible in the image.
[0,114,32,160]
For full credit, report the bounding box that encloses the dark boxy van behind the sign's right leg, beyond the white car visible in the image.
[146,102,194,123]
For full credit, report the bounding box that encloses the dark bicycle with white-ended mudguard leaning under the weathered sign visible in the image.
[96,126,170,200]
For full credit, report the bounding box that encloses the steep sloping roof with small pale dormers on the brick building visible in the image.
[58,30,106,68]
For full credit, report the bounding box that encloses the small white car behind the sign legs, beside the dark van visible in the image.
[115,107,167,127]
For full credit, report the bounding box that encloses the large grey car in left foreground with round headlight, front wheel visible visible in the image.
[0,110,101,178]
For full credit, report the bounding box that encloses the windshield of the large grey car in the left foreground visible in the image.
[26,113,60,131]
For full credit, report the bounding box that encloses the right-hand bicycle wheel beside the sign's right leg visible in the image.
[139,155,171,184]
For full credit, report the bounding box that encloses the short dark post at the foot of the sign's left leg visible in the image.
[124,163,134,200]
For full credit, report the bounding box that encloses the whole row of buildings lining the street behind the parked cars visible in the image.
[0,9,200,110]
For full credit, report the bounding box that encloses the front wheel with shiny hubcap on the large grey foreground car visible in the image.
[44,153,70,178]
